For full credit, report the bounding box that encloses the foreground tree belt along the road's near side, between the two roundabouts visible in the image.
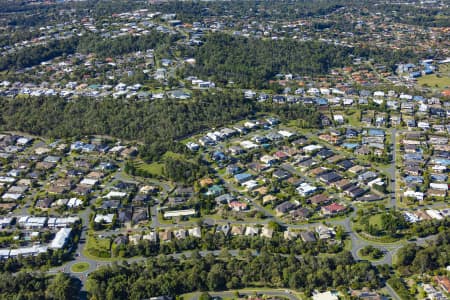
[86,252,381,299]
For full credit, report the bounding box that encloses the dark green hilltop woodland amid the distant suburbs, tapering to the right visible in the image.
[185,33,414,88]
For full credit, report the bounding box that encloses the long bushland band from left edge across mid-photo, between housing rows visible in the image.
[0,92,319,161]
